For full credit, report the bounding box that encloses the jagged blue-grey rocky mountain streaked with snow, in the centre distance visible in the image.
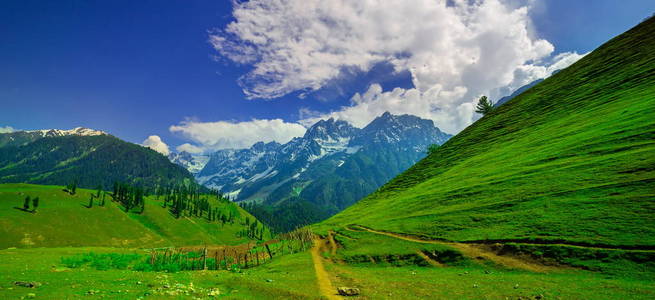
[196,113,450,212]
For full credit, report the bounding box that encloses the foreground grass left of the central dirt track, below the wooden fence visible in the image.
[0,247,318,299]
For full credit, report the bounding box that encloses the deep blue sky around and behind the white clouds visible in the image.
[0,0,655,154]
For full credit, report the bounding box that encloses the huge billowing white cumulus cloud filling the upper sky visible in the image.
[210,0,580,133]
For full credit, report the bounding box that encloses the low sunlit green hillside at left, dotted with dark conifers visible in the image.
[0,184,266,249]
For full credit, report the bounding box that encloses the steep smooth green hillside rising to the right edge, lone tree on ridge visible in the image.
[316,18,655,247]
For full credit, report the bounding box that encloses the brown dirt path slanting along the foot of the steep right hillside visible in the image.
[347,225,558,273]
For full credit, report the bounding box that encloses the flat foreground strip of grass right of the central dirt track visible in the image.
[329,265,655,299]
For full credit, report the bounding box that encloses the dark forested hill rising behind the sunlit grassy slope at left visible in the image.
[0,131,193,188]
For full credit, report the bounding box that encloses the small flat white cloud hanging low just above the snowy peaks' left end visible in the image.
[169,119,306,152]
